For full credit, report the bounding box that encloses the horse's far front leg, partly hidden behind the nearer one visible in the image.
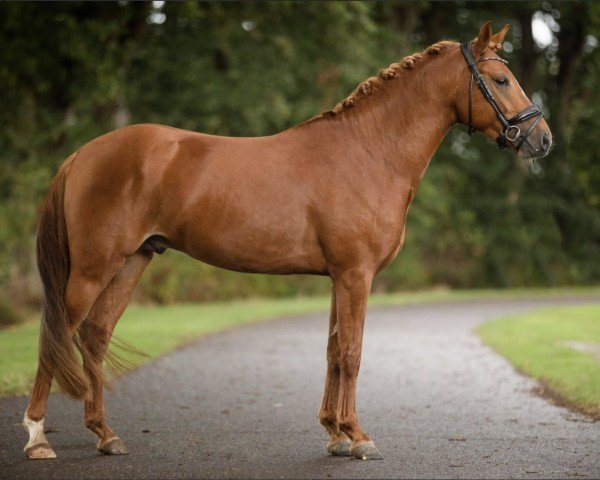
[319,287,352,456]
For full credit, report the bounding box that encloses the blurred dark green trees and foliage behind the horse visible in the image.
[0,2,600,303]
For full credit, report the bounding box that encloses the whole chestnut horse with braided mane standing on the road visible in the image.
[24,22,551,459]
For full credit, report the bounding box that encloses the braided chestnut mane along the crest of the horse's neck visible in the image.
[311,40,456,120]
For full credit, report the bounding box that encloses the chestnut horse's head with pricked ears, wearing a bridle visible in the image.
[458,21,552,158]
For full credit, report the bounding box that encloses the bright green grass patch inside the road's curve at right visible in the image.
[477,305,600,418]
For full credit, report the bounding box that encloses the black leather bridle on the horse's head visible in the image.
[460,42,544,150]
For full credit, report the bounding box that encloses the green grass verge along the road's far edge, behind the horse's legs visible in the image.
[0,288,600,396]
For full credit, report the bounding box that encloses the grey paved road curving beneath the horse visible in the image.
[0,298,600,479]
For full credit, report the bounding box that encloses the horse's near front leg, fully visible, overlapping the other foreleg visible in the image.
[333,269,382,460]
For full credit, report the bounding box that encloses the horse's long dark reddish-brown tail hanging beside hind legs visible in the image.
[36,153,90,399]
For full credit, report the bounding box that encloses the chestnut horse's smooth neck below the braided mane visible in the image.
[300,58,457,188]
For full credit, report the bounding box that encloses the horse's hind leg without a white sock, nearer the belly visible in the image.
[79,253,152,455]
